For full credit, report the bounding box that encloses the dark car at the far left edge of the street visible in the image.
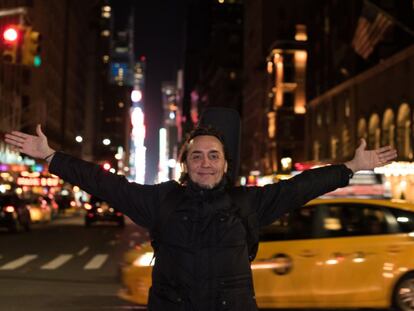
[0,193,31,232]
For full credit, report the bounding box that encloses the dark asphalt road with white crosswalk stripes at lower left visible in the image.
[0,216,150,311]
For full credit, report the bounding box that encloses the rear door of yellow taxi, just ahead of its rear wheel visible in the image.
[313,203,395,307]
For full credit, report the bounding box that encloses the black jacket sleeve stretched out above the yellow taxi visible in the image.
[251,164,352,226]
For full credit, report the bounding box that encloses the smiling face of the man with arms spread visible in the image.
[185,135,227,189]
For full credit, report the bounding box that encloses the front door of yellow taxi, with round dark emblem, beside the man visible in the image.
[252,207,321,308]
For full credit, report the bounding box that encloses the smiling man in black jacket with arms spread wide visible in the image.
[5,125,397,311]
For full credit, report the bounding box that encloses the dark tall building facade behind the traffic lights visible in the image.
[0,1,99,165]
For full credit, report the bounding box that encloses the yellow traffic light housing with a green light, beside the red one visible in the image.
[22,27,42,67]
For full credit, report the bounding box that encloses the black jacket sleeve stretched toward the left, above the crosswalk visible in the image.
[49,152,159,228]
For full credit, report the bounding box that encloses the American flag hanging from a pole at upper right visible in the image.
[352,2,393,59]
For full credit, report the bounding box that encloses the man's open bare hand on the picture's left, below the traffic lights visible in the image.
[4,124,54,159]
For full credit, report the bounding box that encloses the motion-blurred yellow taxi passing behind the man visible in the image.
[119,198,414,311]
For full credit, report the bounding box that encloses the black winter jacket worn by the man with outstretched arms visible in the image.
[49,152,350,311]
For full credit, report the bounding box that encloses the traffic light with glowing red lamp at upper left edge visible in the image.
[1,25,22,64]
